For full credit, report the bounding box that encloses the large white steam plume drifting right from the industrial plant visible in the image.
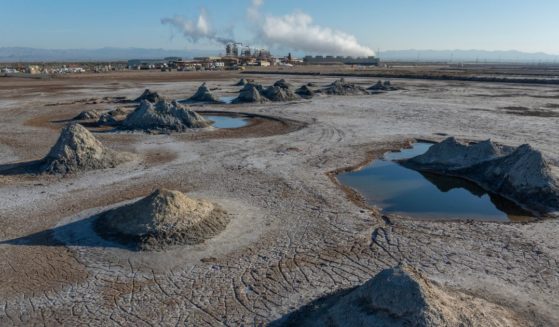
[247,0,375,57]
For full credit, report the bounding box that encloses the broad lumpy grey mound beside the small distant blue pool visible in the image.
[122,100,211,132]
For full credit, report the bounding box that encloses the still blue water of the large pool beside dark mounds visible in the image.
[338,142,530,221]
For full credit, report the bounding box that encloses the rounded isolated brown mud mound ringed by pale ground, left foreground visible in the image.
[94,189,229,250]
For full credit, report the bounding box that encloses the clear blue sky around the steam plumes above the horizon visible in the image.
[0,0,559,54]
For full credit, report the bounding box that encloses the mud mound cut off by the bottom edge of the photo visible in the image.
[282,267,515,327]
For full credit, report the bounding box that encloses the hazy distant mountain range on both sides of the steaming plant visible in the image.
[0,47,559,63]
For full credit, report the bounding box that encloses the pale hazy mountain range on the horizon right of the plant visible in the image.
[379,49,559,63]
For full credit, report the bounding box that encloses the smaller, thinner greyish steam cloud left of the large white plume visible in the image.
[161,9,233,44]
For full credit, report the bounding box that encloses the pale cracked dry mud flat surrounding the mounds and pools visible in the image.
[0,73,559,326]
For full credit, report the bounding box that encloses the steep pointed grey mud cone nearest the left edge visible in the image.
[40,123,131,175]
